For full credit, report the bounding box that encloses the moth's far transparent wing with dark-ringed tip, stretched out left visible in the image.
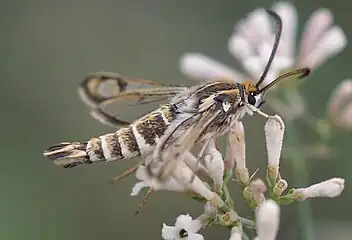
[79,72,186,127]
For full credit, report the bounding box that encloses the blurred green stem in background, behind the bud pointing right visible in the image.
[285,121,314,240]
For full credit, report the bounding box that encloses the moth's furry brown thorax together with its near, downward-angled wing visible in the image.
[148,80,245,180]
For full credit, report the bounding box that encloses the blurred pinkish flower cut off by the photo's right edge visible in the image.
[328,79,352,130]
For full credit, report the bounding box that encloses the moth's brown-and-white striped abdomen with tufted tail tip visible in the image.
[44,105,176,168]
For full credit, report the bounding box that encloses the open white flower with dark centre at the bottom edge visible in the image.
[161,214,204,240]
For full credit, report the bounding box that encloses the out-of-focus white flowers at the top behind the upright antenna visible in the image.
[180,2,347,85]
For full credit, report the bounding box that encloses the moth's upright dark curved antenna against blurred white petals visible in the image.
[255,9,282,89]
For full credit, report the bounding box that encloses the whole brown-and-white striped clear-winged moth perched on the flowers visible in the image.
[44,10,310,180]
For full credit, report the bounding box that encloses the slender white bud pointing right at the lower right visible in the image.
[293,178,345,200]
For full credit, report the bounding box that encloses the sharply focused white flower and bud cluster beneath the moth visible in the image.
[132,116,344,240]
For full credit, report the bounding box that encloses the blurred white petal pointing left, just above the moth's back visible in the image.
[180,53,247,82]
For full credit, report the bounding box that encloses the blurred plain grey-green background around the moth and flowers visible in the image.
[0,0,352,240]
